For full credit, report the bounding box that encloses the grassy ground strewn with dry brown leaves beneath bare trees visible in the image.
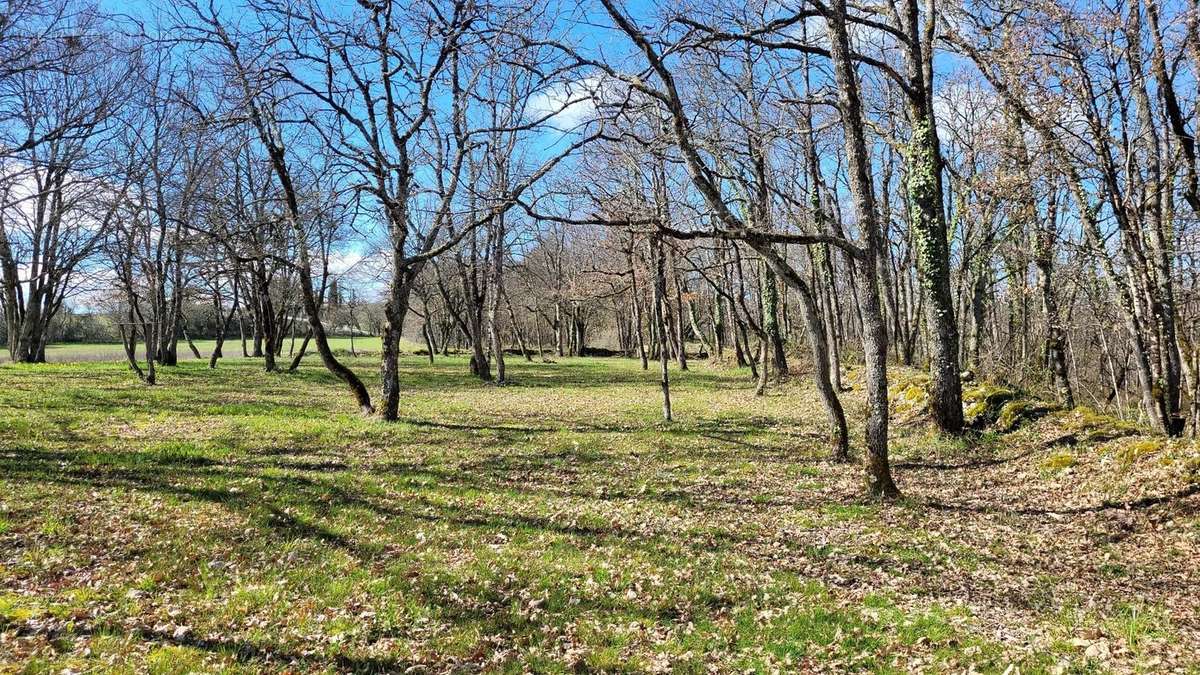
[0,356,1200,673]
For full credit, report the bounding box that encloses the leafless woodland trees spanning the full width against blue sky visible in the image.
[0,0,1200,496]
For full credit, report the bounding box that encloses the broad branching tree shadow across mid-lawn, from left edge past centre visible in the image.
[0,449,758,561]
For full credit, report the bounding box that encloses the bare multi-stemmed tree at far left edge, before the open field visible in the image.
[0,10,136,362]
